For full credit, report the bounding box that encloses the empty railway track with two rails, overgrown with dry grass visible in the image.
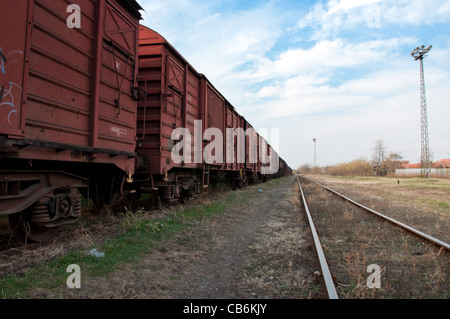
[297,176,450,299]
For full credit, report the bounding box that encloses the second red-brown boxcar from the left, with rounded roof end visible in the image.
[135,26,203,200]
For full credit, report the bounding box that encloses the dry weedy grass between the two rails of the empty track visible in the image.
[298,178,450,299]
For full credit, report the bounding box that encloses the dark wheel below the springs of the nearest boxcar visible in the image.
[8,212,56,243]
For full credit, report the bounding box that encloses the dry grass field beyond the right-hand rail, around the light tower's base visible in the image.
[313,176,450,243]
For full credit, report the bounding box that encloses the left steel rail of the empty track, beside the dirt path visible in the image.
[297,177,339,299]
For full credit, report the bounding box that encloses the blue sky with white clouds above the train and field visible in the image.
[138,0,450,169]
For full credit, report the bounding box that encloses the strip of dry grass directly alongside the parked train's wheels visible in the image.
[0,188,237,276]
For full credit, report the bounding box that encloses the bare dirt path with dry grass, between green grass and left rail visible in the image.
[23,177,319,299]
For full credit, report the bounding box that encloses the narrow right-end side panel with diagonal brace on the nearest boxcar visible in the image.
[98,3,139,152]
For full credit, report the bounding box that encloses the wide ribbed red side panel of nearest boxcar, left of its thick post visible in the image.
[25,1,95,145]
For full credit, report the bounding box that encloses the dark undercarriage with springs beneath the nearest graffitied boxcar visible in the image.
[0,170,87,242]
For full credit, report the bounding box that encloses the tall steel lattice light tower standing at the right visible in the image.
[411,45,431,178]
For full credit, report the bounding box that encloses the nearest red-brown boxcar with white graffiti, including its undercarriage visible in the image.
[0,0,141,239]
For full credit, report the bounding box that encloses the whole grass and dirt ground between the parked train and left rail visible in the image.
[4,178,324,298]
